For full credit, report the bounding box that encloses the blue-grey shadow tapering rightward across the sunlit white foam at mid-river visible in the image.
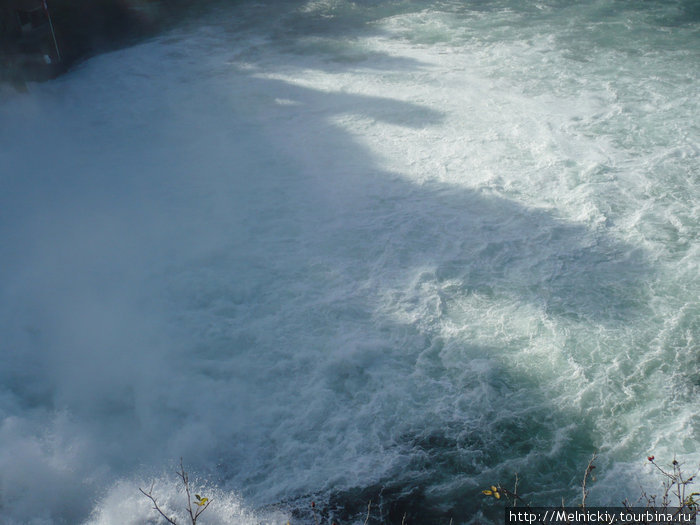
[231,69,649,324]
